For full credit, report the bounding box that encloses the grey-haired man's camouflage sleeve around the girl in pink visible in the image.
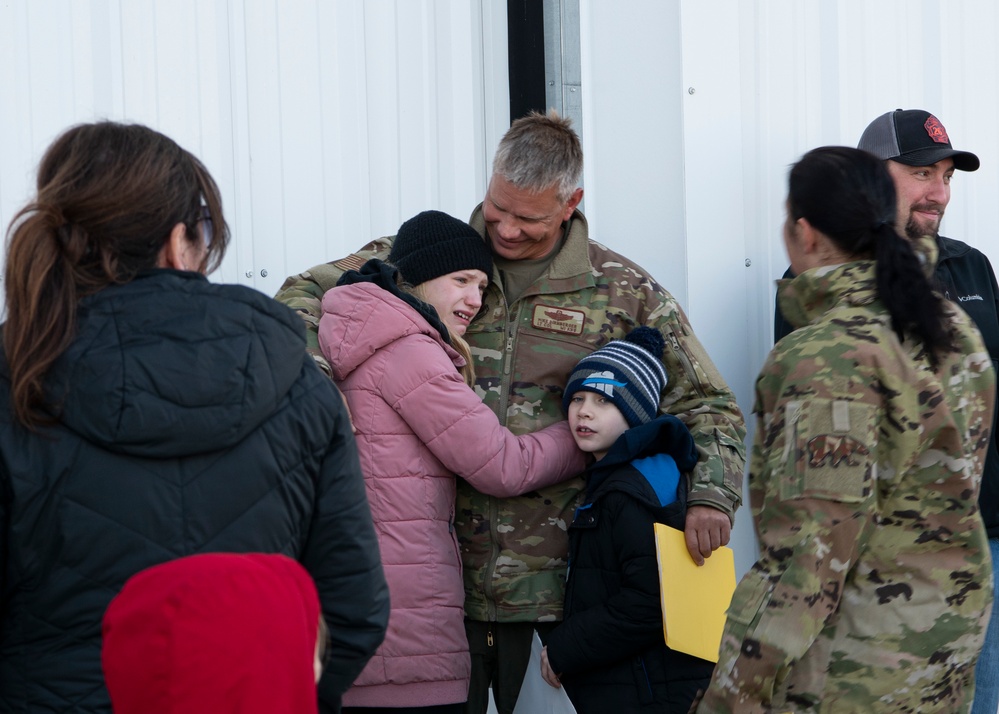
[274,237,392,377]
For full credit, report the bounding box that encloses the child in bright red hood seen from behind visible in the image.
[102,553,322,714]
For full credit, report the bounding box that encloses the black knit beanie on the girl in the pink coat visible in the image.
[388,211,493,286]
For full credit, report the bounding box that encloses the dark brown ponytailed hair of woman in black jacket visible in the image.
[3,122,229,427]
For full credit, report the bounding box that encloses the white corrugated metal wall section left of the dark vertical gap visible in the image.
[0,0,509,294]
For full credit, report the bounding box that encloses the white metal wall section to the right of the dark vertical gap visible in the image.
[580,0,999,574]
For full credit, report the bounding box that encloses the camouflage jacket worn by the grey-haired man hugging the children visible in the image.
[277,206,745,622]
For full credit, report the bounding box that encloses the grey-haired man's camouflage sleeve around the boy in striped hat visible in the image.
[647,296,746,519]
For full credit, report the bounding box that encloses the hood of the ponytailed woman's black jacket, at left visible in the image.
[36,269,308,458]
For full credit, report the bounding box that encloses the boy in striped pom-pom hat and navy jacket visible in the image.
[541,327,714,714]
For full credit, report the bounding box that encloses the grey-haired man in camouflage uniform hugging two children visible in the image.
[277,113,745,714]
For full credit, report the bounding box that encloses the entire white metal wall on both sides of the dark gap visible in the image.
[0,0,999,584]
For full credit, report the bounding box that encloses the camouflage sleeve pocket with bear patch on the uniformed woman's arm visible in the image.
[773,398,878,503]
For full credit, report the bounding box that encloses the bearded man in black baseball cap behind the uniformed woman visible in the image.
[774,109,999,714]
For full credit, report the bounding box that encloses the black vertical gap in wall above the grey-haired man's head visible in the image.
[506,0,546,122]
